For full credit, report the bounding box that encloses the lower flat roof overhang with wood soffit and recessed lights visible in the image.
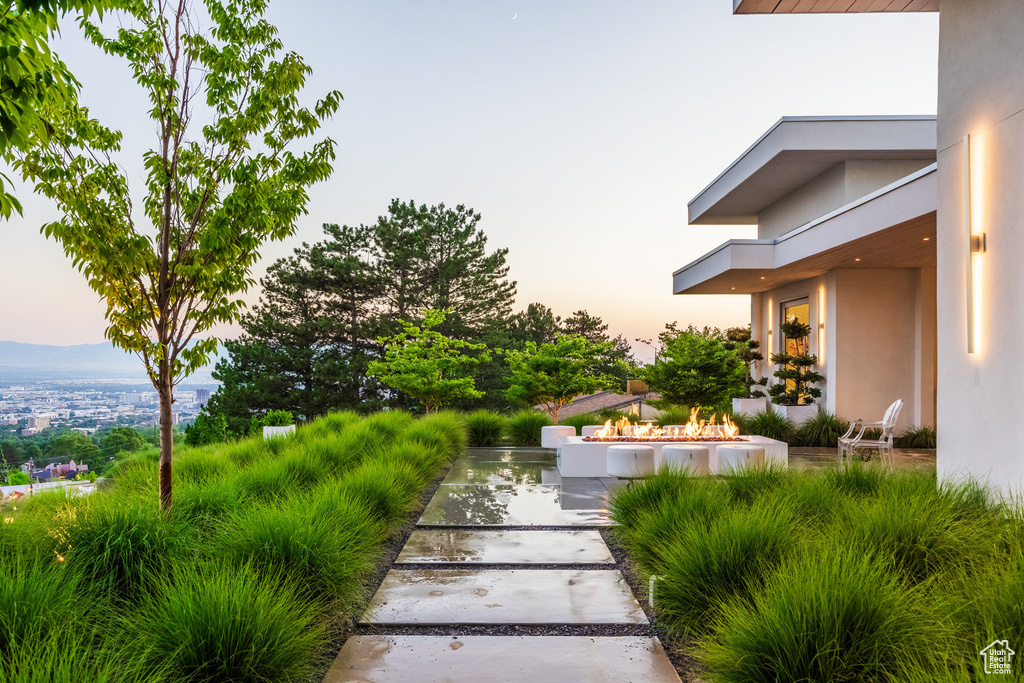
[672,164,938,294]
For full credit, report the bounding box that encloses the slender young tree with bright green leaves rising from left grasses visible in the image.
[14,0,341,511]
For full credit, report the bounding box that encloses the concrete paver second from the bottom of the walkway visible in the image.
[360,568,647,626]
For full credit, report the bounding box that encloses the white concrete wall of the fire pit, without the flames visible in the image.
[557,436,790,477]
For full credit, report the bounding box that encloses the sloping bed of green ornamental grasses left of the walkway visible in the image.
[0,413,466,683]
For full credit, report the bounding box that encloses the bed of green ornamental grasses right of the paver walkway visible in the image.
[612,466,1024,683]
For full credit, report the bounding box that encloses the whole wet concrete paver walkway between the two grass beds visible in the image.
[324,449,679,683]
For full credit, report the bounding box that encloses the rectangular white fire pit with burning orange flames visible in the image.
[558,411,788,477]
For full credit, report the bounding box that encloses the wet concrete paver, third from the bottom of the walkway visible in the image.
[395,528,615,564]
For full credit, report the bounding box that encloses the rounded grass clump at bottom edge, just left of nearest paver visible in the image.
[138,564,324,682]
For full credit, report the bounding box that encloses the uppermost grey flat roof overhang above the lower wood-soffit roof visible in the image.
[687,116,937,225]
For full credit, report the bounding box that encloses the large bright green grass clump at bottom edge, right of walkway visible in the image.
[702,547,940,683]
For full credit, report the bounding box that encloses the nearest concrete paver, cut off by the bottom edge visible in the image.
[324,636,679,683]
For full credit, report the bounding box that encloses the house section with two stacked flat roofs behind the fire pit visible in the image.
[673,117,937,426]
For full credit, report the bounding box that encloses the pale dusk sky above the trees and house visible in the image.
[0,0,938,360]
